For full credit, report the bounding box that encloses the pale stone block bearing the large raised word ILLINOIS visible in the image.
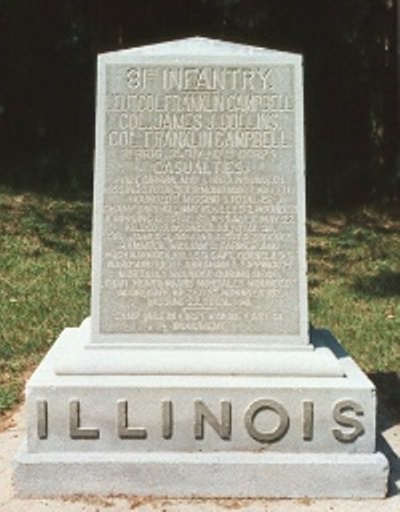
[27,328,376,453]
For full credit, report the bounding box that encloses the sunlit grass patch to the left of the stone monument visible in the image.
[0,193,91,411]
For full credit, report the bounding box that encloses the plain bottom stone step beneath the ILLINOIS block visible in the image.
[14,446,389,498]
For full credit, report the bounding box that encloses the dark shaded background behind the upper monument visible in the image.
[0,0,399,207]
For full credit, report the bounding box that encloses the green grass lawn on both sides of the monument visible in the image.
[0,191,400,412]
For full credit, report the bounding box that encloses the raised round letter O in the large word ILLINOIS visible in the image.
[244,400,289,443]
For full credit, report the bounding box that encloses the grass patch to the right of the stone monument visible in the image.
[308,209,400,373]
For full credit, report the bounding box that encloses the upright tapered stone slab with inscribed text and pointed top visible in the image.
[92,38,308,346]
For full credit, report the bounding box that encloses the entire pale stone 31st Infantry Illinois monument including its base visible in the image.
[14,38,388,497]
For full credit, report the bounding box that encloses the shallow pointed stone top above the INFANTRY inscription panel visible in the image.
[100,36,300,63]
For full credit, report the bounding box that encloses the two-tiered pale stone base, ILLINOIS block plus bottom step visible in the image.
[14,329,388,497]
